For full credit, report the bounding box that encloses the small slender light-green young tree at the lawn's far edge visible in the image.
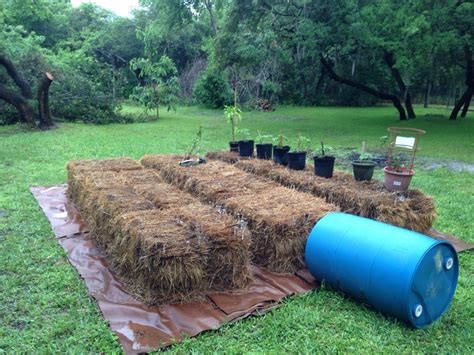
[130,56,179,119]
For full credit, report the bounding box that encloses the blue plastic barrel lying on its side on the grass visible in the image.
[305,212,459,328]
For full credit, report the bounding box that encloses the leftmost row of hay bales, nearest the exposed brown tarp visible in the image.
[68,161,250,304]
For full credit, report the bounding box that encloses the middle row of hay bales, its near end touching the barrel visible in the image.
[141,155,338,273]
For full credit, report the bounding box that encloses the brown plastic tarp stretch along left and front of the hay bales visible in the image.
[30,185,319,353]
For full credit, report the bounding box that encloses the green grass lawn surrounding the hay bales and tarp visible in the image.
[0,106,474,353]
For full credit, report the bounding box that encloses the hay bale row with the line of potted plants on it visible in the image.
[206,152,437,233]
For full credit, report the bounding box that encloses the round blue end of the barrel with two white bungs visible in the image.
[408,241,459,328]
